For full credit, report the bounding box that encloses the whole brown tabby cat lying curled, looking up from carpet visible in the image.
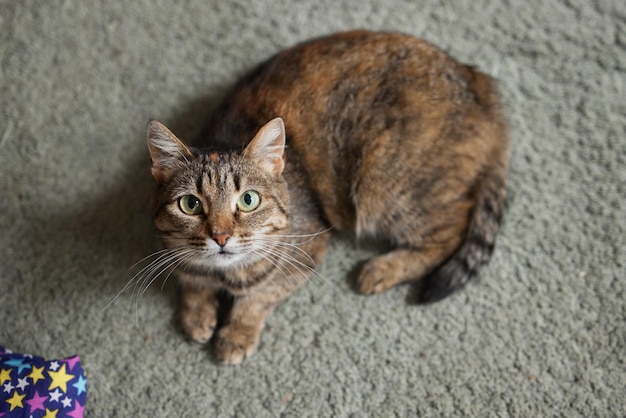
[147,31,509,363]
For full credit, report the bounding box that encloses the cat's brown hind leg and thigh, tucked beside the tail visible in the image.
[354,166,472,294]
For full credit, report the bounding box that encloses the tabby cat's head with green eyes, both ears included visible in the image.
[147,118,289,270]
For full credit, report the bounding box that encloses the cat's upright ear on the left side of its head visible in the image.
[146,120,191,182]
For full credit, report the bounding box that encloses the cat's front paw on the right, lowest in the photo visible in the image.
[215,324,260,364]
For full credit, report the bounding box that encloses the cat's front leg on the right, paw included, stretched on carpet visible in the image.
[215,292,282,364]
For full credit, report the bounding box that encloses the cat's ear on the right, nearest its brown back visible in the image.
[242,118,285,175]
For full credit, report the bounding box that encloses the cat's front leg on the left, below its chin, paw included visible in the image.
[178,284,218,344]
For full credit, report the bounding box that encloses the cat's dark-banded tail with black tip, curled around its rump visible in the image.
[418,158,506,303]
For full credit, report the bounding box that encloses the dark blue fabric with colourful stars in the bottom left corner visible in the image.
[0,347,87,418]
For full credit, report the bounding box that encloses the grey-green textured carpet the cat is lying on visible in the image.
[0,0,626,417]
